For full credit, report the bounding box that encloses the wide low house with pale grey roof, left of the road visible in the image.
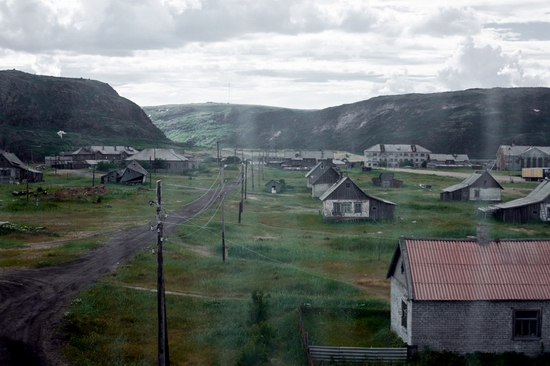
[126,149,199,174]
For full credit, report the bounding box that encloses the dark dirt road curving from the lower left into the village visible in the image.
[0,180,240,366]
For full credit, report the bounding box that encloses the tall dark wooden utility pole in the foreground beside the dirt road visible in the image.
[157,180,170,366]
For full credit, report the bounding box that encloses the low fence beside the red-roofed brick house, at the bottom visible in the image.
[298,304,415,366]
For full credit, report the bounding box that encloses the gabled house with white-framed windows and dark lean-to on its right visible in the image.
[319,177,397,220]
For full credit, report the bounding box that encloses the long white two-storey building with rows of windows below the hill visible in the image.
[364,144,431,167]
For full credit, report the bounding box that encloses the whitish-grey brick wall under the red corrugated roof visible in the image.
[410,298,550,356]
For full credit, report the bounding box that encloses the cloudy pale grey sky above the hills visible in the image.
[0,0,550,109]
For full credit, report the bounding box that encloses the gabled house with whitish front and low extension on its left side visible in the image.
[439,171,503,202]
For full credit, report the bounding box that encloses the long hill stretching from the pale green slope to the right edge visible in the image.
[144,88,550,158]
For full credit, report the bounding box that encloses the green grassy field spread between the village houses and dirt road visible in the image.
[0,166,550,365]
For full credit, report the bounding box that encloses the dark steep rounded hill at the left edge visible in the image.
[0,70,169,161]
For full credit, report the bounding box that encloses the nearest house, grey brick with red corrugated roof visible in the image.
[387,237,550,356]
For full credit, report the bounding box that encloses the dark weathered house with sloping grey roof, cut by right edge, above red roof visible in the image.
[478,180,550,224]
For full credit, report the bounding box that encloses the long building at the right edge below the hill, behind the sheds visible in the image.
[495,145,550,171]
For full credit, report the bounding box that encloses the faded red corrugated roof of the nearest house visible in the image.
[400,238,550,300]
